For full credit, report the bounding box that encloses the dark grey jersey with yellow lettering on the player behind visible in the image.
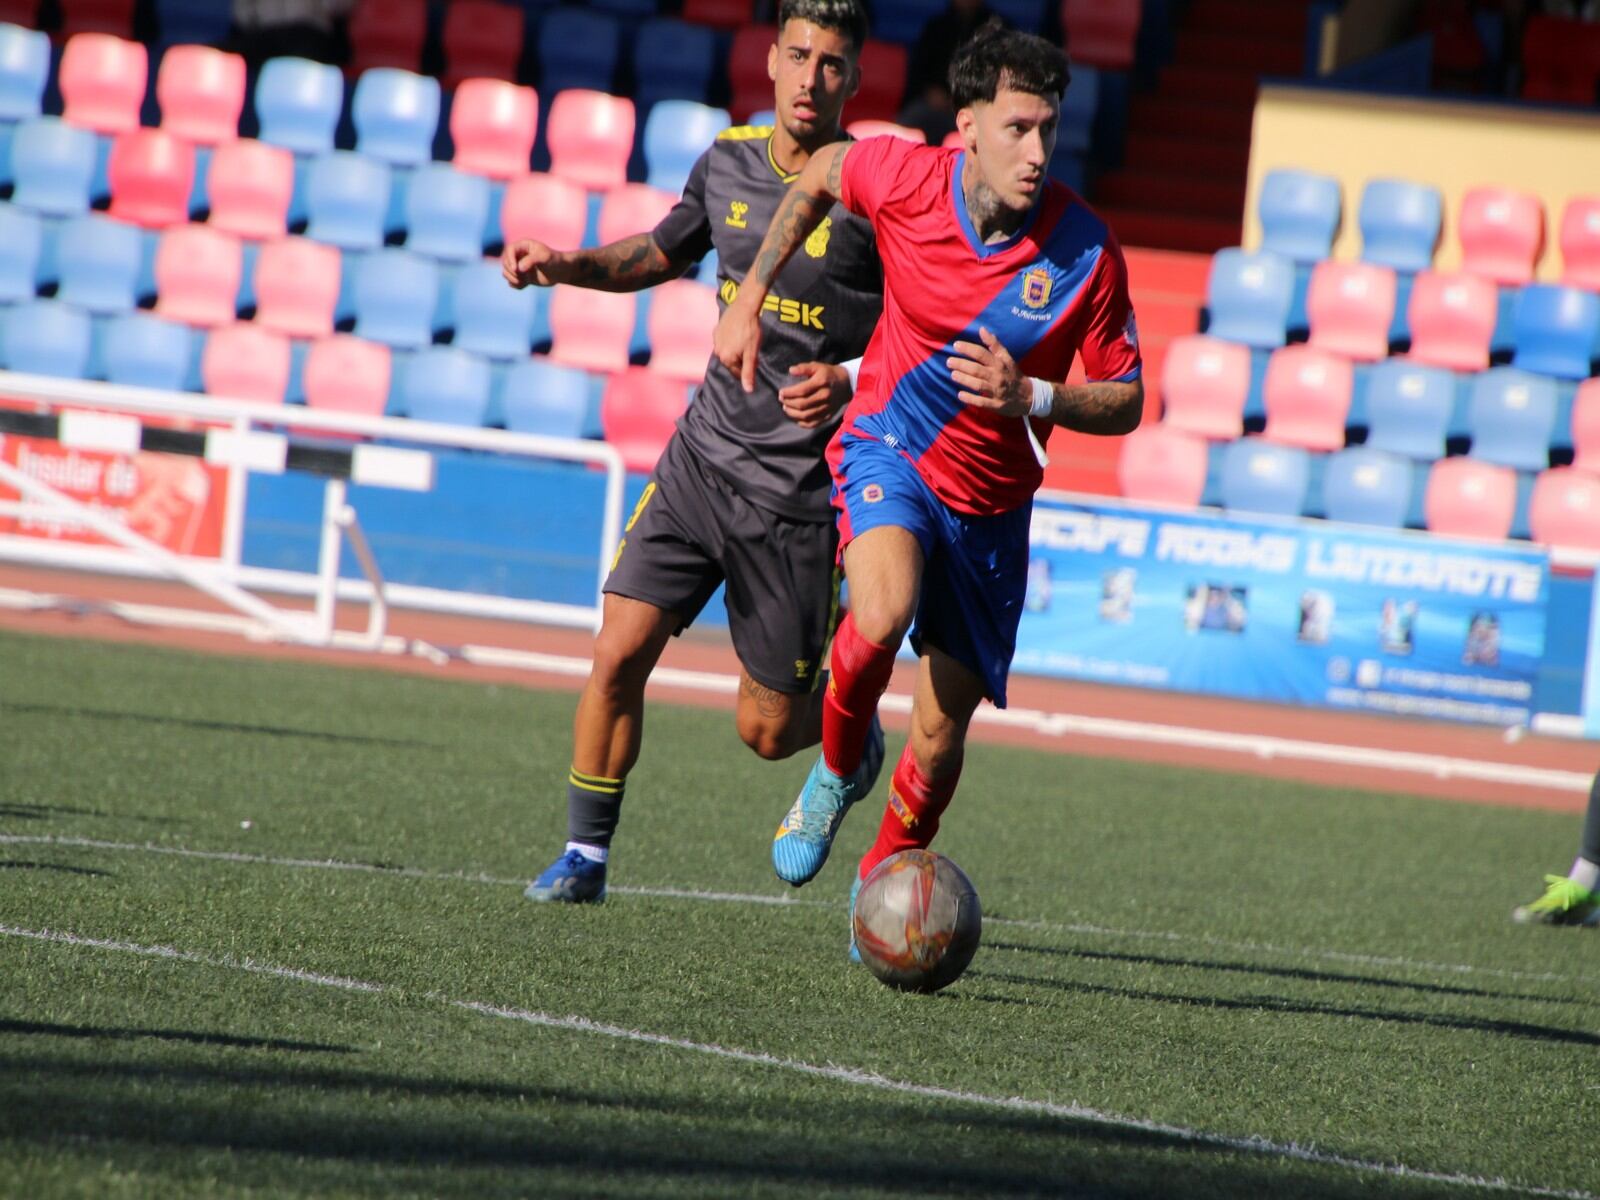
[653,125,883,520]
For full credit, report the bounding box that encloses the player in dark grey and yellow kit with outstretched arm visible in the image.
[502,0,883,902]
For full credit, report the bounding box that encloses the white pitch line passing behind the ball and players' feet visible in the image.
[0,834,1600,987]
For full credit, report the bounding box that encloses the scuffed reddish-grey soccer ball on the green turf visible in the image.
[853,850,984,992]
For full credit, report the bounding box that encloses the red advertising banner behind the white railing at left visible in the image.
[0,437,227,558]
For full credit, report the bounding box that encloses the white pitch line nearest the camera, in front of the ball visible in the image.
[0,925,1600,1200]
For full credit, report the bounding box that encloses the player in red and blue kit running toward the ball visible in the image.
[714,18,1144,947]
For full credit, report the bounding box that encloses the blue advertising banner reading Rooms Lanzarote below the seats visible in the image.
[1013,498,1549,725]
